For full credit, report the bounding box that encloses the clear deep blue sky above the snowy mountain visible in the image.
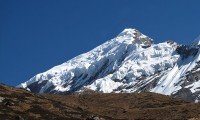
[0,0,200,86]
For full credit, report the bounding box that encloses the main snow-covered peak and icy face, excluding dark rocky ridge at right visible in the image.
[18,29,178,93]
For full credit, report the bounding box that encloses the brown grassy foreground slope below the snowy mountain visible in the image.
[0,84,200,120]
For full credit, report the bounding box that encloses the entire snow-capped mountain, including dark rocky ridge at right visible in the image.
[17,29,200,102]
